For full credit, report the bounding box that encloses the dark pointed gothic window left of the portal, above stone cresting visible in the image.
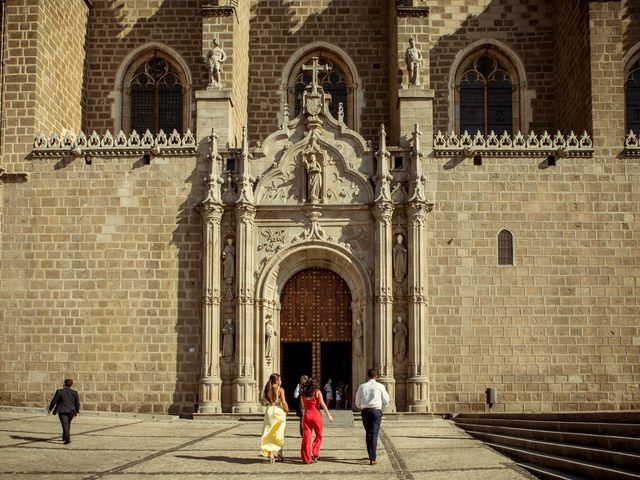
[123,51,186,134]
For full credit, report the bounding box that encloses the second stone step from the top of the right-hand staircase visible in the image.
[456,422,640,453]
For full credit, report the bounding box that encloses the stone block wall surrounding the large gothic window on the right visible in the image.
[429,0,555,135]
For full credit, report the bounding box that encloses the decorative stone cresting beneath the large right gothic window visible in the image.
[433,130,593,157]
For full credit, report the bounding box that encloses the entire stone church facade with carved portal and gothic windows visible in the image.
[0,0,640,415]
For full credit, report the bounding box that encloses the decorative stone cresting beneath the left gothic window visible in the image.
[32,129,196,157]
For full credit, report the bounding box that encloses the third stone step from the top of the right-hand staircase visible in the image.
[467,432,640,472]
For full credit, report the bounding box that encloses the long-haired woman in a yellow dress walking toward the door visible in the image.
[260,373,289,463]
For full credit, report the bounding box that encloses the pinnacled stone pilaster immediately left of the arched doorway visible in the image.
[233,129,259,413]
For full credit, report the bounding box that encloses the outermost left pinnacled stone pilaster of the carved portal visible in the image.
[197,131,224,414]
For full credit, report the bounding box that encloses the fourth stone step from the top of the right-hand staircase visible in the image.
[486,442,640,480]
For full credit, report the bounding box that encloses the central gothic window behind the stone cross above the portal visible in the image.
[288,50,354,128]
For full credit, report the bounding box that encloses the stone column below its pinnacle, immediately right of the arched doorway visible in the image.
[373,201,396,412]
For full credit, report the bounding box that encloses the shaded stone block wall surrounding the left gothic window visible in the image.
[83,0,201,133]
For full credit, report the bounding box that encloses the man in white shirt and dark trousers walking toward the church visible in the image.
[356,368,389,465]
